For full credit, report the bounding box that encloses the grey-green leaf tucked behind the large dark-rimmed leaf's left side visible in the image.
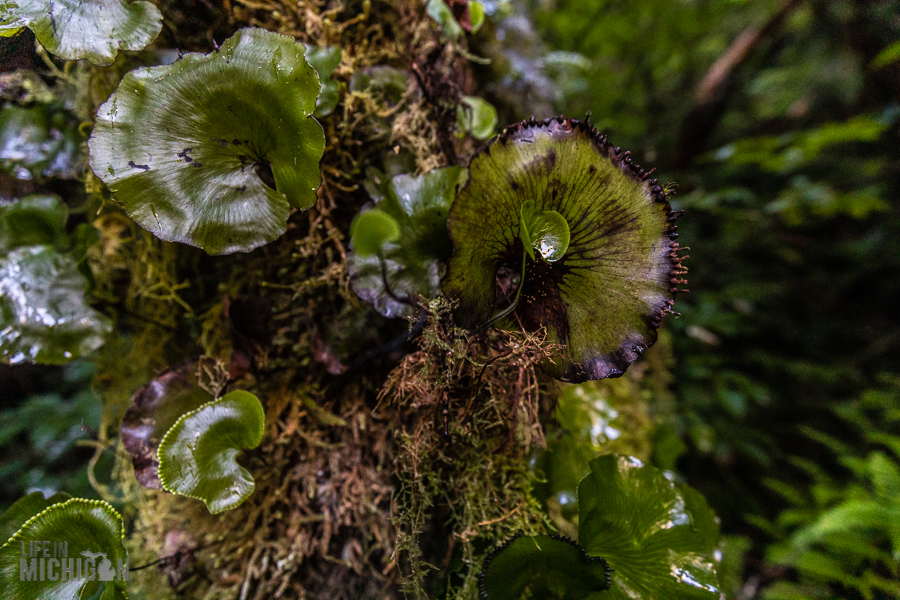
[347,167,465,318]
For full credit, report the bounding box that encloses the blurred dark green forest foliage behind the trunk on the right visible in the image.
[478,0,900,598]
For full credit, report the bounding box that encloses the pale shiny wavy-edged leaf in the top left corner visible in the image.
[0,0,162,65]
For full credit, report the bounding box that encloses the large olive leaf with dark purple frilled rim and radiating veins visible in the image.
[442,118,680,382]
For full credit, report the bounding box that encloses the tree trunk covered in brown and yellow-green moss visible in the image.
[63,0,666,600]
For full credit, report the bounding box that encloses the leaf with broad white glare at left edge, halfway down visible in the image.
[0,246,112,364]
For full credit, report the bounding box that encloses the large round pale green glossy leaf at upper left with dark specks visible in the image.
[88,28,325,254]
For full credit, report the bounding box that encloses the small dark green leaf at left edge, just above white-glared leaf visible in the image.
[0,196,69,254]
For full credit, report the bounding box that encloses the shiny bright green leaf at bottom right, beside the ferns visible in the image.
[578,455,719,600]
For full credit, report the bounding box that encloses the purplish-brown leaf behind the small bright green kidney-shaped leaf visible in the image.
[120,361,213,489]
